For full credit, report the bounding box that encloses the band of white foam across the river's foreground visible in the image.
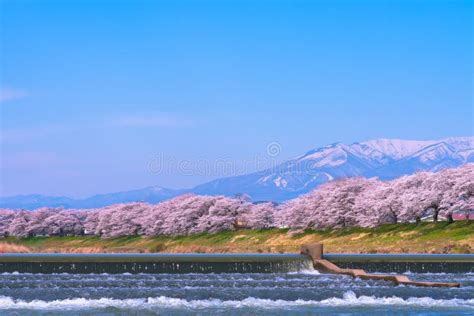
[0,291,474,312]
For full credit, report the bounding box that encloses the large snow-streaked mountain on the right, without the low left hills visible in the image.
[193,137,474,201]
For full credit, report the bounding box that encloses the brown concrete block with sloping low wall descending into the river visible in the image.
[301,244,460,287]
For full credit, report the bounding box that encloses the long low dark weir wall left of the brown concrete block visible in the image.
[0,253,312,274]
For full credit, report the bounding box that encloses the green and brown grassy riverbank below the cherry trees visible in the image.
[0,221,474,253]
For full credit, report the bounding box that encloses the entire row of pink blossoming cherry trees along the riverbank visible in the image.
[0,164,474,237]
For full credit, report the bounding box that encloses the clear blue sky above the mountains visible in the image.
[0,0,474,197]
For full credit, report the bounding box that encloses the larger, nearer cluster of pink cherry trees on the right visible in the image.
[283,164,474,228]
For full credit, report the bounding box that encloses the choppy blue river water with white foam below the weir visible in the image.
[0,270,474,315]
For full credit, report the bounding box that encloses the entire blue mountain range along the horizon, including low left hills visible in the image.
[0,136,474,209]
